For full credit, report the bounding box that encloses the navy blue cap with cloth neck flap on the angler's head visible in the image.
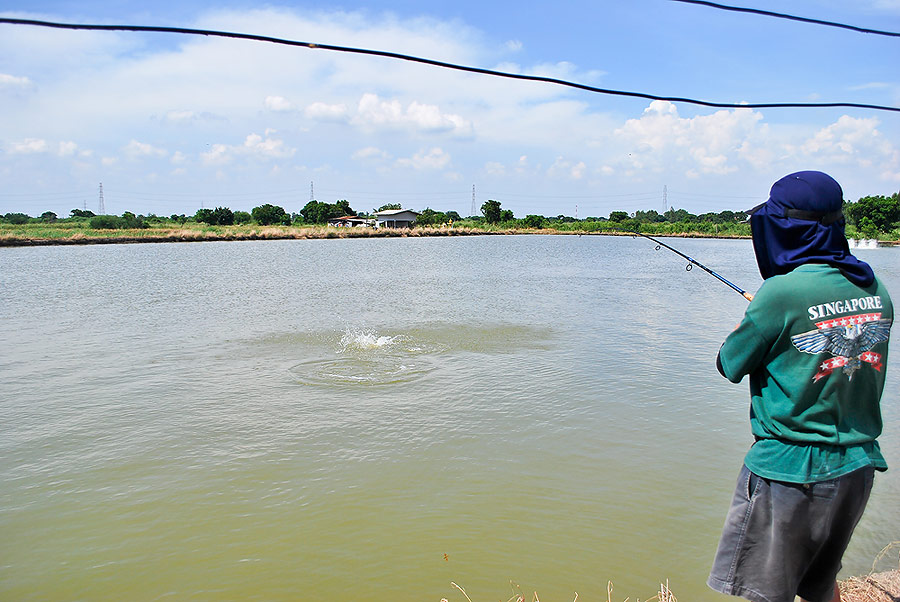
[750,171,875,287]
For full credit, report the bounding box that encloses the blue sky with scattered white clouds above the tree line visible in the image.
[0,0,900,218]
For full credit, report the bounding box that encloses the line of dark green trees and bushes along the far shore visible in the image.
[0,192,900,238]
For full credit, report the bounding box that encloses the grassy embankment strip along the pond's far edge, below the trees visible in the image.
[0,219,900,246]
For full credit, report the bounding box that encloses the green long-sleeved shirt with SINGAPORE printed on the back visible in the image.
[719,264,894,483]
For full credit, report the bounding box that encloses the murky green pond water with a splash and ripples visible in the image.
[0,236,900,602]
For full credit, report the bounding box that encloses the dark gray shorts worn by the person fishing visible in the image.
[707,466,875,602]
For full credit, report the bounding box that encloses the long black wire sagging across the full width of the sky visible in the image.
[0,17,900,113]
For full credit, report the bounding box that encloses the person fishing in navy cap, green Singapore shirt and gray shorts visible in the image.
[708,171,894,602]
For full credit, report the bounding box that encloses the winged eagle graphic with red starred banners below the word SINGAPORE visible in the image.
[791,313,891,381]
